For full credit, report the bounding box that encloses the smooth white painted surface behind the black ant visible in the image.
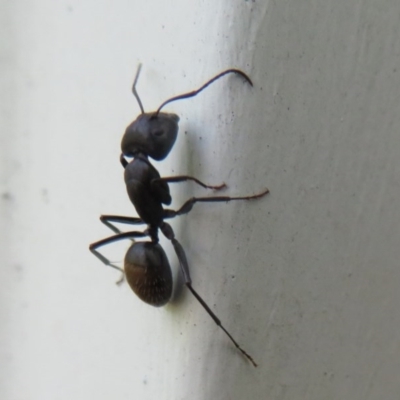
[0,0,400,400]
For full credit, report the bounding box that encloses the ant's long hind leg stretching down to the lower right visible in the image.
[160,222,257,367]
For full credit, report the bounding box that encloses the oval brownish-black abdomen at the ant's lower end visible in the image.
[124,242,172,307]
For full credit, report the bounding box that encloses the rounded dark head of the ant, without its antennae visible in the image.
[121,112,179,161]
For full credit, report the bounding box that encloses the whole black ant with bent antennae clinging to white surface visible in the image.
[89,65,268,366]
